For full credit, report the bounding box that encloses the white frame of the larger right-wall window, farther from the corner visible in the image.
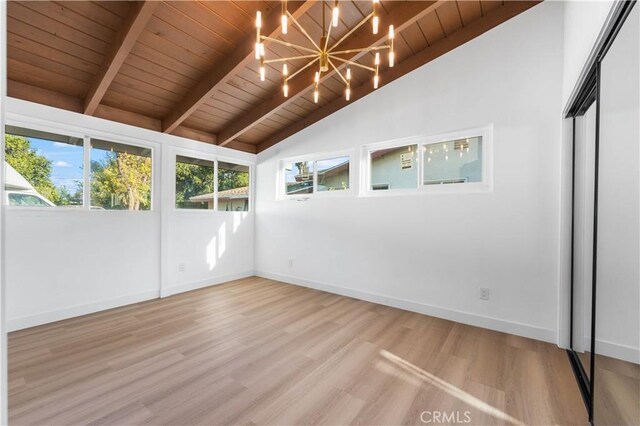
[360,124,493,197]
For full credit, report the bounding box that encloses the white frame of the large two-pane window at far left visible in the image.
[0,116,161,215]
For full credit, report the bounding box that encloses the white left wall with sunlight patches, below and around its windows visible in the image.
[4,99,255,330]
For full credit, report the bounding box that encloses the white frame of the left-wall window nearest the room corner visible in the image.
[169,148,254,215]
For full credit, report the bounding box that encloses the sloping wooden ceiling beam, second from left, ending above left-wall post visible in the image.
[162,0,314,133]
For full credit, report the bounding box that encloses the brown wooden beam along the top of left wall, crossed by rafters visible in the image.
[7,80,256,154]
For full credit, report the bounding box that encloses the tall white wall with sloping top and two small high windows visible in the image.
[255,2,564,342]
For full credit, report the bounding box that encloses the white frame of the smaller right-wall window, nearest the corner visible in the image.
[277,149,355,201]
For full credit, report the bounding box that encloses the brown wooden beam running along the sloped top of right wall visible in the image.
[255,0,541,152]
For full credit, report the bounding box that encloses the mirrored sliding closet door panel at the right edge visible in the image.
[593,5,640,425]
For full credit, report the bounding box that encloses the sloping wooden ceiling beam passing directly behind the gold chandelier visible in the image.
[218,0,443,146]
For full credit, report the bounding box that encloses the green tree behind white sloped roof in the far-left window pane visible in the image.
[4,135,63,205]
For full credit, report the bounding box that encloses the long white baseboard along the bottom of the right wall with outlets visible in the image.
[255,271,557,344]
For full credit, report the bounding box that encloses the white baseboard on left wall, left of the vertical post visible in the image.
[7,290,159,331]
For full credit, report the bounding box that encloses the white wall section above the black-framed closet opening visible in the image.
[562,0,615,105]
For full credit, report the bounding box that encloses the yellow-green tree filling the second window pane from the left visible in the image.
[91,152,151,210]
